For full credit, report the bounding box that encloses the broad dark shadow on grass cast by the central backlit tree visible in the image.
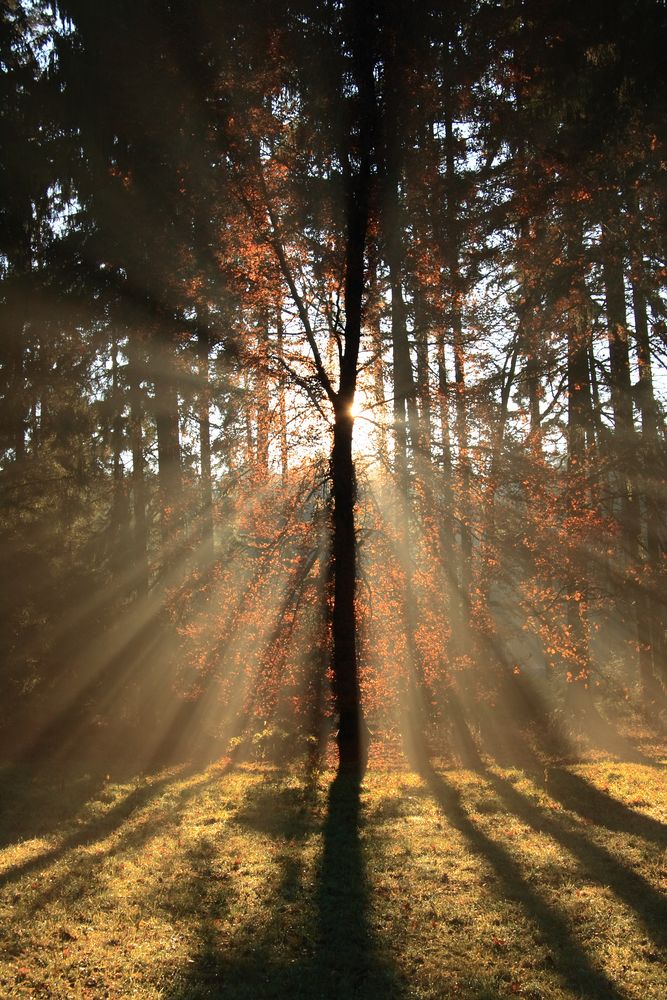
[163,775,405,1000]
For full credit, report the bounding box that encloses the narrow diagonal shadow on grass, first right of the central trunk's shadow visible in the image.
[420,761,623,1000]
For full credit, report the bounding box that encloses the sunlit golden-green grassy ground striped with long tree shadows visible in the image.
[0,732,667,1000]
